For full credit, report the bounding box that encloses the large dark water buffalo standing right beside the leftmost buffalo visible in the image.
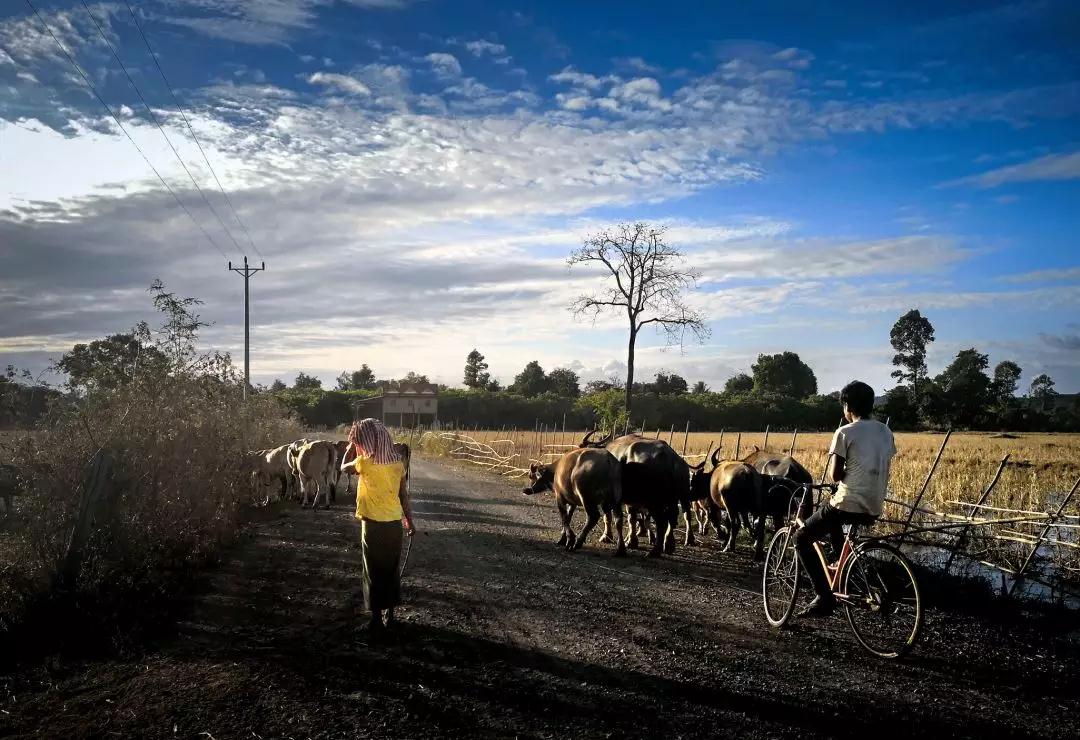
[578,431,693,553]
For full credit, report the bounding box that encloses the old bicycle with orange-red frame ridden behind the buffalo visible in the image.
[761,484,922,658]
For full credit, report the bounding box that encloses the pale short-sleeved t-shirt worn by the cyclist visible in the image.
[828,419,896,516]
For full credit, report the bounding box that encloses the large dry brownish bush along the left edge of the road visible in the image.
[0,283,301,648]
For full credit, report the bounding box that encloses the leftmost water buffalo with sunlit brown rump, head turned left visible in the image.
[522,448,626,555]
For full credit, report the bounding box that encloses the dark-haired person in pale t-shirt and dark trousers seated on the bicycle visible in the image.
[795,380,896,617]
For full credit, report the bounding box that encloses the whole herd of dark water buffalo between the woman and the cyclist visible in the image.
[524,431,813,560]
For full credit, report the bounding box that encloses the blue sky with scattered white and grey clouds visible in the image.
[0,0,1080,392]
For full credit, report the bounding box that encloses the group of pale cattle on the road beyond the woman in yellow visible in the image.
[244,440,411,509]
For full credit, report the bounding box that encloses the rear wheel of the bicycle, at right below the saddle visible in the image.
[840,542,922,658]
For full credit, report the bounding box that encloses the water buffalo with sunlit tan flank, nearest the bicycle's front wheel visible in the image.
[690,449,791,561]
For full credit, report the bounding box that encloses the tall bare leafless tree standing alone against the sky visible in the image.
[567,221,708,417]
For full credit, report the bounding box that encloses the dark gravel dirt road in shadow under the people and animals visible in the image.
[0,459,1080,740]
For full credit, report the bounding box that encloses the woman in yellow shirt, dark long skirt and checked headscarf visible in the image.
[341,419,416,631]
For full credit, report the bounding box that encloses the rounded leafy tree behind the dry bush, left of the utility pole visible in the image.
[56,332,170,390]
